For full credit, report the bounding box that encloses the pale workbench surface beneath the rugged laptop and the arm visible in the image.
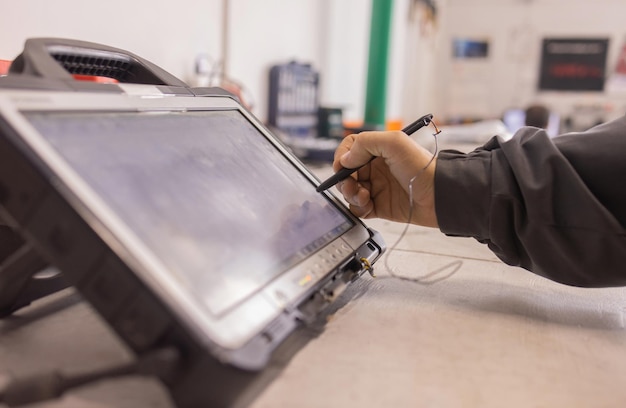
[0,163,626,408]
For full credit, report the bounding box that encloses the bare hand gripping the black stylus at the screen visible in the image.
[333,131,438,227]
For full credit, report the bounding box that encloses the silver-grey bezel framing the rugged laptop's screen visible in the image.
[0,91,370,350]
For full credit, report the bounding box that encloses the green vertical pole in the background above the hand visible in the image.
[363,0,393,129]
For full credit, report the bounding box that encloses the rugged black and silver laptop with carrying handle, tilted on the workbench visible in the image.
[0,39,385,406]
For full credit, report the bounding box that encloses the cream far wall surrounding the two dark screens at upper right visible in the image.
[433,0,626,123]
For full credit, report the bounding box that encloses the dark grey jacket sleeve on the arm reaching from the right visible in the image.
[435,117,626,287]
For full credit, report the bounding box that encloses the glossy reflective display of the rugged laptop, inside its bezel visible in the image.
[26,110,354,316]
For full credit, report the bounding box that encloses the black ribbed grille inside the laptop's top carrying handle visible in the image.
[50,53,134,82]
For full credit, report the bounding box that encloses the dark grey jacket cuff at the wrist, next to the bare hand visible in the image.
[435,150,492,240]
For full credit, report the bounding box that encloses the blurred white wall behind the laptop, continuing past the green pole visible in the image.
[0,0,409,126]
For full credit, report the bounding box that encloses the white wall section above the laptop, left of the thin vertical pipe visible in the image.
[0,0,222,84]
